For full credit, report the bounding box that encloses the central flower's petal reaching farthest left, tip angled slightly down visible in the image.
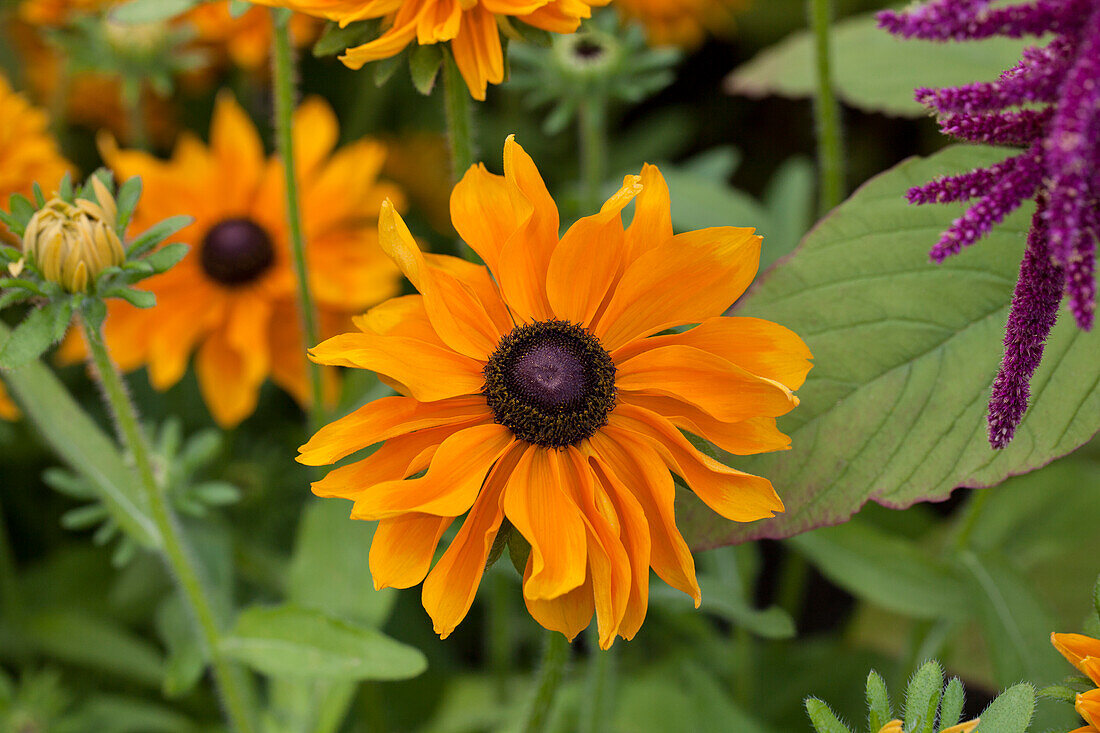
[298,397,492,466]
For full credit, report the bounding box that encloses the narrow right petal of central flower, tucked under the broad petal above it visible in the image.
[618,392,791,456]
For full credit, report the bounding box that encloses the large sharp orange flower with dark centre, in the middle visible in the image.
[299,139,811,648]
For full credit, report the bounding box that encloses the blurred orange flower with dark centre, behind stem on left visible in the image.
[61,94,403,426]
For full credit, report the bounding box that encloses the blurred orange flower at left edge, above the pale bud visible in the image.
[0,75,73,238]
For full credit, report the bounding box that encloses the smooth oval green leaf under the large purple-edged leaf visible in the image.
[789,519,969,619]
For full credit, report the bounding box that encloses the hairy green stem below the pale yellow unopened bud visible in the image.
[83,318,255,733]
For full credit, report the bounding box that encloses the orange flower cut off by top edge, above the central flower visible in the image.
[245,0,609,100]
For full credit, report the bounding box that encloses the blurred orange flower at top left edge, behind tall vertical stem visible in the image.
[180,2,320,72]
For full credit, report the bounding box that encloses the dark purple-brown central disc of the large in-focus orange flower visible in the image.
[484,320,615,448]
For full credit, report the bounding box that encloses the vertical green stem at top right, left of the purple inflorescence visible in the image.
[809,0,844,214]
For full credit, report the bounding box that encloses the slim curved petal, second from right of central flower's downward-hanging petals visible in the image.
[587,455,651,641]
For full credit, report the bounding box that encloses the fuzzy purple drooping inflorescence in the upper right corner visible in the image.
[879,0,1100,448]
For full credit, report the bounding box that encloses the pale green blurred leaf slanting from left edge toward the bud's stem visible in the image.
[0,324,160,547]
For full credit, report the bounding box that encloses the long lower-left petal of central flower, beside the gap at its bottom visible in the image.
[422,435,525,638]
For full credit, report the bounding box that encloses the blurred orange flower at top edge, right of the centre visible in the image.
[615,0,748,48]
